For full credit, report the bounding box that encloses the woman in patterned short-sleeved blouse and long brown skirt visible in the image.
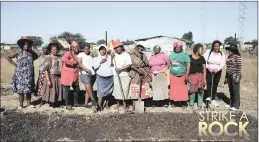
[42,43,63,107]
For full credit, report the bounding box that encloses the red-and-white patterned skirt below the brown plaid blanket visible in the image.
[130,82,152,99]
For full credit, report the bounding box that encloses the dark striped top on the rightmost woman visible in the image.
[226,54,242,76]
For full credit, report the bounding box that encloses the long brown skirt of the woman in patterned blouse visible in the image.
[42,74,63,103]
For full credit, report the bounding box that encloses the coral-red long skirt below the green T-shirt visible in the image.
[169,74,189,101]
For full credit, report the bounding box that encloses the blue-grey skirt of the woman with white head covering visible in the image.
[97,75,114,97]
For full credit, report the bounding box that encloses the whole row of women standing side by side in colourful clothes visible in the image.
[8,37,244,110]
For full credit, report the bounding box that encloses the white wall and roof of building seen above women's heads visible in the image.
[136,37,187,51]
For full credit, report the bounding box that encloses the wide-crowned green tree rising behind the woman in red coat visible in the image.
[50,32,86,49]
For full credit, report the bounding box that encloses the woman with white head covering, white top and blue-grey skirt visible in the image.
[96,45,114,110]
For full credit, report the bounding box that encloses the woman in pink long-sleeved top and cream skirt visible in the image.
[149,45,170,105]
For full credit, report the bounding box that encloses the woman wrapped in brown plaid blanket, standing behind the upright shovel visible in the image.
[130,45,152,109]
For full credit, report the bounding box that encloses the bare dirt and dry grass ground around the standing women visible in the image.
[1,52,258,141]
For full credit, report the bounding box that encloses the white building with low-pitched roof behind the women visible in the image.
[135,35,187,52]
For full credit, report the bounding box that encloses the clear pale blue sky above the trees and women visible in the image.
[1,2,258,43]
